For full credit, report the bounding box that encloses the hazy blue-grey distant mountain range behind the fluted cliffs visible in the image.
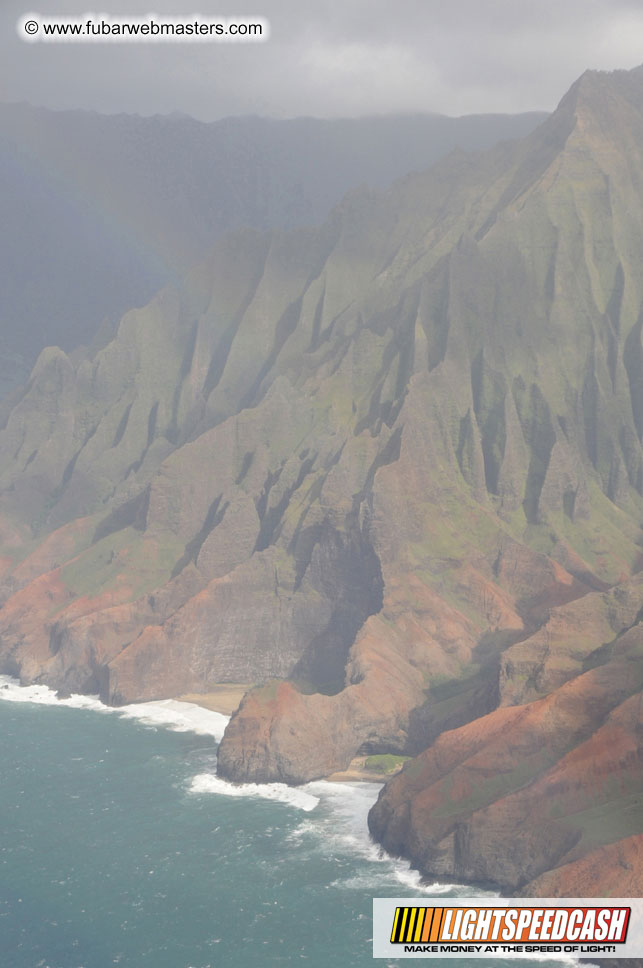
[0,104,543,394]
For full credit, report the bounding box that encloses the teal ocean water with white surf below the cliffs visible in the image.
[0,677,580,968]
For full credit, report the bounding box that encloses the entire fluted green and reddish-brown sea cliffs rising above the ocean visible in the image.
[0,70,643,889]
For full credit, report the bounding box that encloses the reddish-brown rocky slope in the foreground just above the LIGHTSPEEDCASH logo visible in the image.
[369,581,643,897]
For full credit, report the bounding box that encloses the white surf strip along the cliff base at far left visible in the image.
[0,676,230,740]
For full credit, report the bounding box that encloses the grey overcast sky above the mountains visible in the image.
[0,0,643,121]
